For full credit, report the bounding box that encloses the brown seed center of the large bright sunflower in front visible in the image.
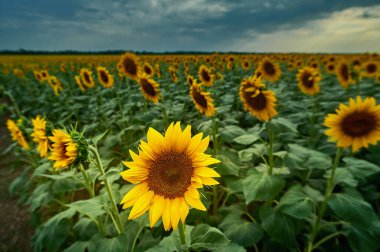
[148,152,194,199]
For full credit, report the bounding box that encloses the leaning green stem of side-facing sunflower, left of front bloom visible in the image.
[88,145,124,234]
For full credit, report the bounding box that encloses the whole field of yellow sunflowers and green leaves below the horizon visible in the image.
[0,52,380,252]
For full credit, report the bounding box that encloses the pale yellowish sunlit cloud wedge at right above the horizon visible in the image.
[229,5,380,52]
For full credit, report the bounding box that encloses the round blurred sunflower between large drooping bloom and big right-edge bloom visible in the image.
[297,66,321,95]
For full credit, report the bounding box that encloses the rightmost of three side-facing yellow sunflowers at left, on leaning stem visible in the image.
[49,129,78,170]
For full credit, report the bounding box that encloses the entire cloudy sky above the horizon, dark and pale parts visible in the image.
[0,0,380,53]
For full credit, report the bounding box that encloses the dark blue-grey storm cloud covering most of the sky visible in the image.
[0,0,379,51]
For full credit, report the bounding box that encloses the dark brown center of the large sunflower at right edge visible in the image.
[341,111,376,137]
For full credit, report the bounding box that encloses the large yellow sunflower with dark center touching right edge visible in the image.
[324,96,380,152]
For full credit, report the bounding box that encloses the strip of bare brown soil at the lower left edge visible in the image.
[0,116,34,252]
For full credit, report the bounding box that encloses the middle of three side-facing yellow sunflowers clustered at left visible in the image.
[31,115,49,157]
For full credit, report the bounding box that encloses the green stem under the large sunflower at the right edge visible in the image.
[305,148,342,252]
